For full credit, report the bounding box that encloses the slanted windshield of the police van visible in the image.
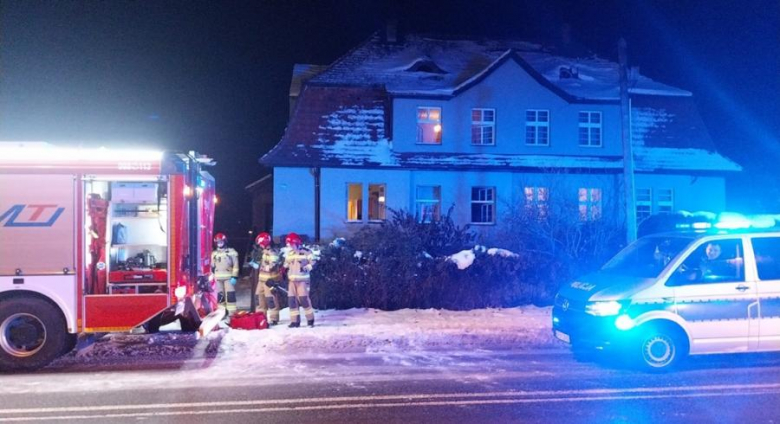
[601,236,693,278]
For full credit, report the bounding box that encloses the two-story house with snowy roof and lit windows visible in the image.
[260,35,740,238]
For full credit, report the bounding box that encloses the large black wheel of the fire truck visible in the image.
[0,297,69,371]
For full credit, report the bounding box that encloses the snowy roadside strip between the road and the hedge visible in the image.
[48,306,560,367]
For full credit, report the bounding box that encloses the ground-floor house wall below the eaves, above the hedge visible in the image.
[274,168,622,240]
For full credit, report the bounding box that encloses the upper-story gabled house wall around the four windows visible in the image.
[392,60,621,156]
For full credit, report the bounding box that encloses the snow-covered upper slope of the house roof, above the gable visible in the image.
[311,35,691,101]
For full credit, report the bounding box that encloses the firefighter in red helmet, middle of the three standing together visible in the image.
[250,233,282,325]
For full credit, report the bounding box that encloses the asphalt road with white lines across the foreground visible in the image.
[0,351,780,424]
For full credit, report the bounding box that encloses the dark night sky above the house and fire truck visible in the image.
[0,0,780,238]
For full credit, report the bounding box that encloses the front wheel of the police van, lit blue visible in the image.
[639,325,688,372]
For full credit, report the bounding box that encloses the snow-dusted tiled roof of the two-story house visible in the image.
[260,36,741,172]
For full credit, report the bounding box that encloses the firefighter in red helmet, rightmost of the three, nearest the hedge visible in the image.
[284,233,314,328]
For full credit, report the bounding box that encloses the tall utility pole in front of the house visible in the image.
[618,38,637,243]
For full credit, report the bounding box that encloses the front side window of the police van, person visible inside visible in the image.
[670,239,745,286]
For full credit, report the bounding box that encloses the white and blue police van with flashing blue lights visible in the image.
[552,216,780,370]
